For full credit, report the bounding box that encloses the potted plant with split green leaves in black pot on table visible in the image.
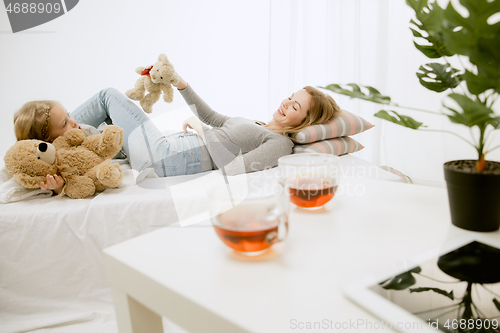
[320,0,500,231]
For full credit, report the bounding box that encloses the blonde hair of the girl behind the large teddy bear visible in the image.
[14,101,54,142]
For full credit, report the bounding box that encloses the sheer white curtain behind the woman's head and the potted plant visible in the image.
[269,0,500,186]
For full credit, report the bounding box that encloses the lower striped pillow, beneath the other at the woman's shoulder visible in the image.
[292,136,365,156]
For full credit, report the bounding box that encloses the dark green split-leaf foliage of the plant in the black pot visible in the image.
[322,0,500,160]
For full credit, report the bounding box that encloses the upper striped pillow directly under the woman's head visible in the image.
[292,110,373,143]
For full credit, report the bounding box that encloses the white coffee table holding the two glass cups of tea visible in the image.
[104,177,490,333]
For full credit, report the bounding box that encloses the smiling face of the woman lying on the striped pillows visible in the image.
[273,89,311,127]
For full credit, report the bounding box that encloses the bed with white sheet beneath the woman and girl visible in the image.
[0,155,403,333]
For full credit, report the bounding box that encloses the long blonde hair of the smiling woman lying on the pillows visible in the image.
[282,86,341,142]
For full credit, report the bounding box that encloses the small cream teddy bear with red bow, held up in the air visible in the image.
[125,54,180,113]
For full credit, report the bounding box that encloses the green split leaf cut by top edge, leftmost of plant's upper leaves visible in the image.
[406,0,454,59]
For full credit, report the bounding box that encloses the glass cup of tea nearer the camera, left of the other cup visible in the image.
[210,182,289,256]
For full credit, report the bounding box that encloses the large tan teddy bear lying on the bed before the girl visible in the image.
[4,125,123,199]
